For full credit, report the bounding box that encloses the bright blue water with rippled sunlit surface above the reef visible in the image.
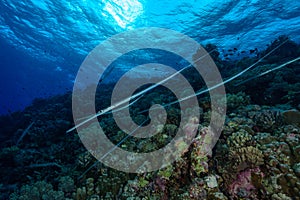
[0,0,300,114]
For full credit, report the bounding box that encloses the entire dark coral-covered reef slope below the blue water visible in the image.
[0,37,300,200]
